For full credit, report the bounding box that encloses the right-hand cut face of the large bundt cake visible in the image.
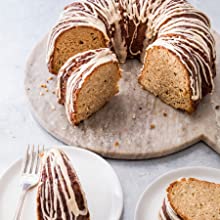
[138,46,198,113]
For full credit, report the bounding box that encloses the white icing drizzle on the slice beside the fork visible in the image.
[39,149,88,220]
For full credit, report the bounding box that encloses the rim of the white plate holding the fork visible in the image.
[0,145,124,220]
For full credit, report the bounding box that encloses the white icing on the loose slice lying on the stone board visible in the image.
[57,48,118,123]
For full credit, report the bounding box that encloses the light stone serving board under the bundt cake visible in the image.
[25,33,220,159]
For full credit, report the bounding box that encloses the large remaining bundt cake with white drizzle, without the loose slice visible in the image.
[47,0,216,117]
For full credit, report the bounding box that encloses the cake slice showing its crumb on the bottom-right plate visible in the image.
[160,178,220,220]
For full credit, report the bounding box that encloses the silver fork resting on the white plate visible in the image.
[14,145,44,220]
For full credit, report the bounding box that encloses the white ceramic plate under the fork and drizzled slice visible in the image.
[0,147,123,220]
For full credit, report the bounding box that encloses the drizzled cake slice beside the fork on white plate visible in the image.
[37,149,90,220]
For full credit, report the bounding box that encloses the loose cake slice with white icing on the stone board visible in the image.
[57,48,121,125]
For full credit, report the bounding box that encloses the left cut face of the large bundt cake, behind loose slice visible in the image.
[47,26,109,75]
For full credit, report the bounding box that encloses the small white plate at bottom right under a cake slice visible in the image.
[135,167,220,220]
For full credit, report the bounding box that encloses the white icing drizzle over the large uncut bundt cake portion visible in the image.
[47,0,216,101]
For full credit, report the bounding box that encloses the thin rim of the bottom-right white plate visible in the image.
[134,166,220,220]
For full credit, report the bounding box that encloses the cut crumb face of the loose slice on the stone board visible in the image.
[70,62,121,125]
